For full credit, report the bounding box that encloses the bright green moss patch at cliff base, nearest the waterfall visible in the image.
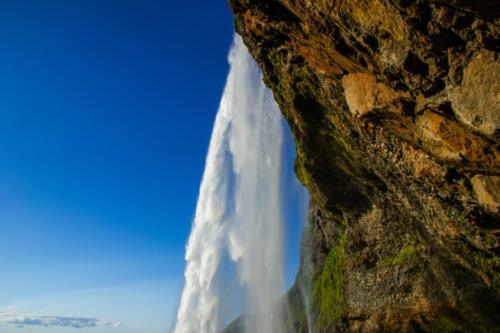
[313,232,346,329]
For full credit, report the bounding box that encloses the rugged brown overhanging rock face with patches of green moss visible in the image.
[230,0,500,333]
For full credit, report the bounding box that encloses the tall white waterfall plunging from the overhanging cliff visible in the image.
[174,35,284,333]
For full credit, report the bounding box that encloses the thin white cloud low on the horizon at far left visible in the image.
[0,310,121,328]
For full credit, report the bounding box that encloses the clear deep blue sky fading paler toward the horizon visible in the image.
[0,0,300,333]
